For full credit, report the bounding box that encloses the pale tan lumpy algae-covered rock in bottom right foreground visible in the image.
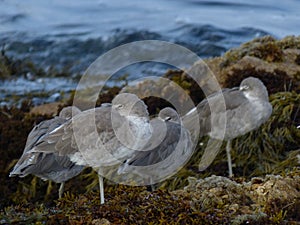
[180,170,300,224]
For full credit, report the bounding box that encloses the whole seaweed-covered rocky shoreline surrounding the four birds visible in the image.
[0,36,300,224]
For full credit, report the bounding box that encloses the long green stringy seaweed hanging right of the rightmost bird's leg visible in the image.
[232,92,300,176]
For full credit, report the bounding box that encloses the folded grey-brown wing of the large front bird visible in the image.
[29,106,122,156]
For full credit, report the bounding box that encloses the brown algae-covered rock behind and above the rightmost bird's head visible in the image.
[205,36,300,94]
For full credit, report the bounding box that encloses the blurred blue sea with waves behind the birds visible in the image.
[0,0,300,105]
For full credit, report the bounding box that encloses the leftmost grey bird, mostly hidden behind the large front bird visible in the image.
[9,106,84,198]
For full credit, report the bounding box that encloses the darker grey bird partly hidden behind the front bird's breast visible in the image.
[118,107,194,186]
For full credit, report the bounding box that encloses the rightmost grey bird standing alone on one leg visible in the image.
[182,77,272,177]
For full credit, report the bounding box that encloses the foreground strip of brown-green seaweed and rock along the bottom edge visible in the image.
[0,170,300,224]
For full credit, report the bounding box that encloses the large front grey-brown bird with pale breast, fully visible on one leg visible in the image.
[30,93,151,204]
